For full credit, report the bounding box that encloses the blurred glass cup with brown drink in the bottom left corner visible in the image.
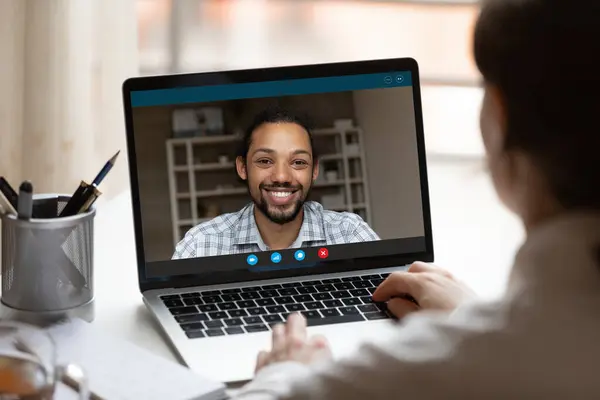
[0,321,90,400]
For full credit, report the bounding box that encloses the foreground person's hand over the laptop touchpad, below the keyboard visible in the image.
[256,313,331,372]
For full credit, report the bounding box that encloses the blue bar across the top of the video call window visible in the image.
[131,71,412,107]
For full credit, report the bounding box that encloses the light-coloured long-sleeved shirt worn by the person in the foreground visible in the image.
[236,214,600,400]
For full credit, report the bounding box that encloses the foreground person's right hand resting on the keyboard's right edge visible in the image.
[373,262,475,318]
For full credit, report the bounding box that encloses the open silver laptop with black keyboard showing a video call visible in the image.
[123,58,433,382]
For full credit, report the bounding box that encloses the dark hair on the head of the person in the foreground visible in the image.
[474,0,600,209]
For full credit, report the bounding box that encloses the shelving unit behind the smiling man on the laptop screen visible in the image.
[166,127,371,244]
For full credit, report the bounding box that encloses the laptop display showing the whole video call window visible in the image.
[131,71,426,277]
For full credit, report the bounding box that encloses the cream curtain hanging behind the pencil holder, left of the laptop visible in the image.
[0,0,138,200]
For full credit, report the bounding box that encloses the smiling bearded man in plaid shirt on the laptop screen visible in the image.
[173,108,379,259]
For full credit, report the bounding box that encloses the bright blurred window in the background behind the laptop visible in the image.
[137,0,483,159]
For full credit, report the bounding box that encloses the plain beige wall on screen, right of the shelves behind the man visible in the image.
[354,87,424,239]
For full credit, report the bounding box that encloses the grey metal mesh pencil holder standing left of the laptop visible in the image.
[2,195,96,325]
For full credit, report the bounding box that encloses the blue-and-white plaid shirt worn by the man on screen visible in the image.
[173,201,379,259]
